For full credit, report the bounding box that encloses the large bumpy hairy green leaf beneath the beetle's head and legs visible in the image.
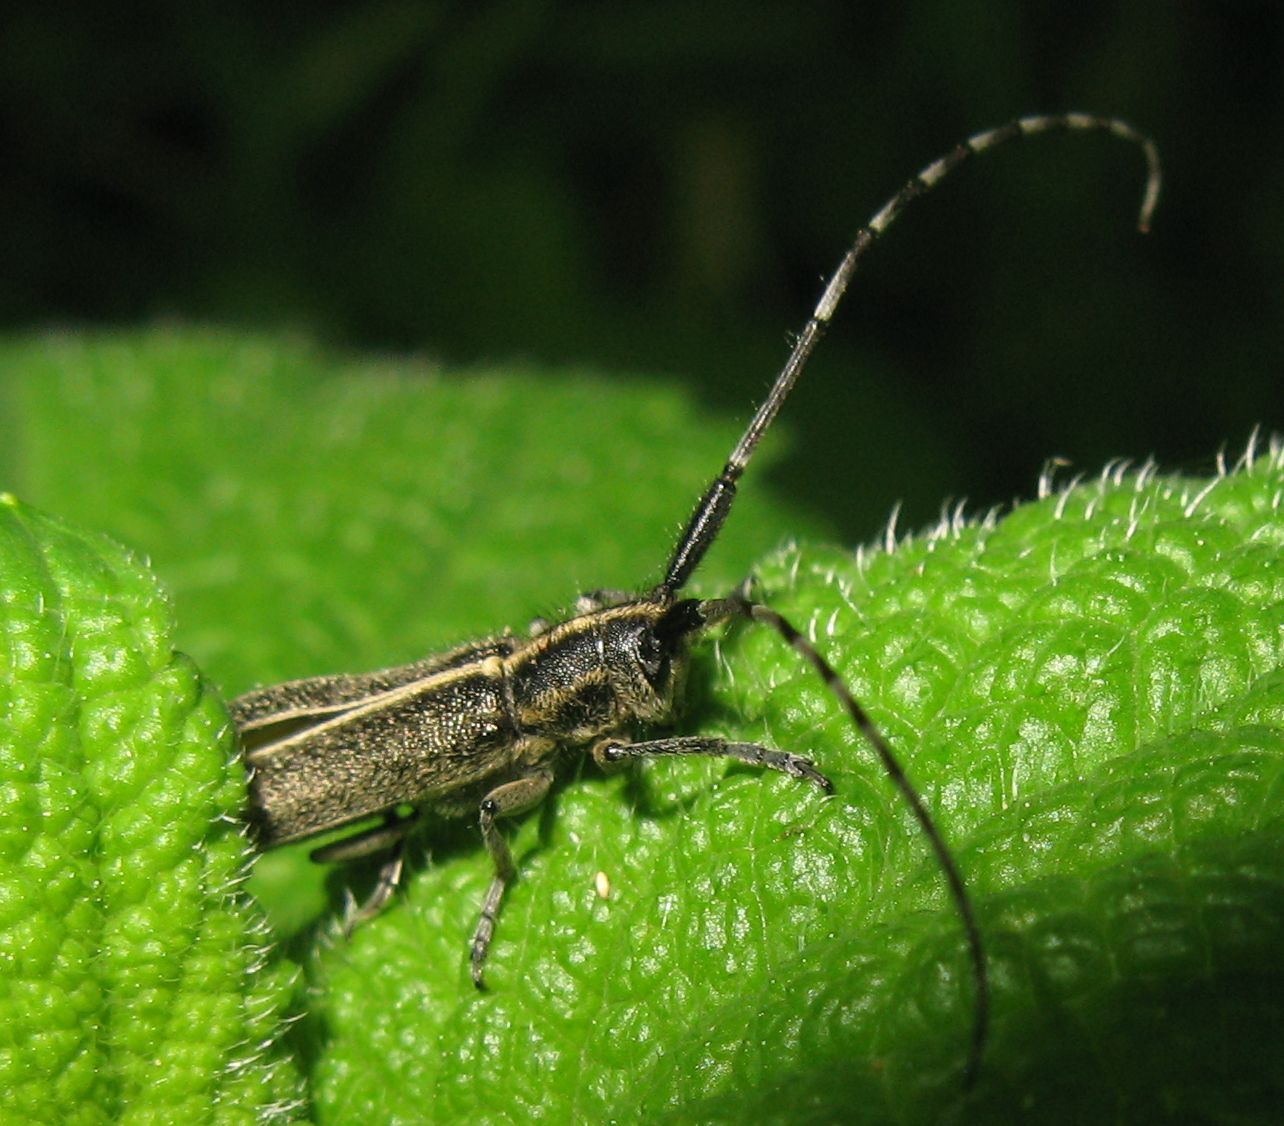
[308,444,1284,1122]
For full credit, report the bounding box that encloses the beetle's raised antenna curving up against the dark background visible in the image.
[656,113,1162,598]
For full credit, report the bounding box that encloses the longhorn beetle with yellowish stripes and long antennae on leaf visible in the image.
[231,113,1159,1082]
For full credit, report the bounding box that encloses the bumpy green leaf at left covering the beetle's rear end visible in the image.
[0,494,299,1123]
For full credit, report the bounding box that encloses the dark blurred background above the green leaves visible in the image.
[0,0,1284,541]
